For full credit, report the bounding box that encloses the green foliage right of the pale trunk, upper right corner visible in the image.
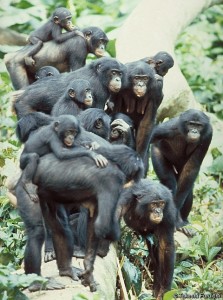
[176,5,223,119]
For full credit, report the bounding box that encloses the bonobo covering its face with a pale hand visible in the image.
[109,113,135,149]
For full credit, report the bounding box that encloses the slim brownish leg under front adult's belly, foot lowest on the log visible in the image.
[80,213,99,292]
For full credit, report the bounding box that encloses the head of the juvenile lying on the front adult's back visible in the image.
[53,115,81,148]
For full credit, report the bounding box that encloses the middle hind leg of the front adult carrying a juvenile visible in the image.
[40,195,80,280]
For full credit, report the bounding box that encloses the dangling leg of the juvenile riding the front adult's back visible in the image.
[20,153,39,202]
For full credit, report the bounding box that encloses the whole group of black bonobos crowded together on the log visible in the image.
[5,8,212,299]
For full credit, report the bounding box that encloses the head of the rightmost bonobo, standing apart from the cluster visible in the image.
[179,109,209,143]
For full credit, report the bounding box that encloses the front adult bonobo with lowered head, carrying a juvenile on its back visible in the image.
[16,139,143,291]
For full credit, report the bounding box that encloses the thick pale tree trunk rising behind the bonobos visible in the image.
[116,0,223,120]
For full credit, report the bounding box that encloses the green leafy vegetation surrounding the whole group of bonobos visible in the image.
[0,0,223,300]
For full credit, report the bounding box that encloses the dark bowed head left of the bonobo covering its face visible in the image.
[77,108,111,140]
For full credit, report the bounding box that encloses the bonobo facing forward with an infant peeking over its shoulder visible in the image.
[108,61,163,172]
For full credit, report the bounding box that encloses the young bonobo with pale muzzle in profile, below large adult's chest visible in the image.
[51,79,93,116]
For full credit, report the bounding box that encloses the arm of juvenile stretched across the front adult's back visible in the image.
[50,134,108,167]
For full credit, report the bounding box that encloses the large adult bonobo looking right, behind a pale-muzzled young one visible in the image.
[14,57,125,119]
